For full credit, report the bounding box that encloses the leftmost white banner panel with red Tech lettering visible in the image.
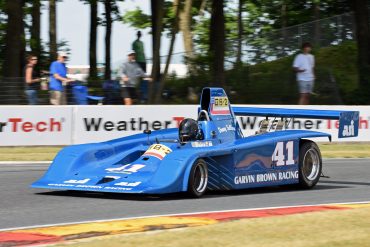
[0,106,73,146]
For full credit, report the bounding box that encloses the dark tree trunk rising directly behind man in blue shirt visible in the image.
[49,0,58,61]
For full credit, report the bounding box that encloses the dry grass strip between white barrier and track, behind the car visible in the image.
[0,143,370,161]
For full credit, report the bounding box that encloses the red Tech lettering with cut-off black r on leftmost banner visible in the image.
[0,117,64,133]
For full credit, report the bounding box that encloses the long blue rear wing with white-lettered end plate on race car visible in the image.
[232,106,359,138]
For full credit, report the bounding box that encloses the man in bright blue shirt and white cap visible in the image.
[49,52,73,105]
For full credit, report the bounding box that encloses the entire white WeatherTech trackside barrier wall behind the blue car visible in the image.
[0,105,370,146]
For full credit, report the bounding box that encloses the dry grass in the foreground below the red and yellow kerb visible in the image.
[57,208,370,247]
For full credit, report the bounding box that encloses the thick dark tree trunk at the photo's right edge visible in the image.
[352,0,370,104]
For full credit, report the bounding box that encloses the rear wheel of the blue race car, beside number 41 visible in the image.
[299,140,322,189]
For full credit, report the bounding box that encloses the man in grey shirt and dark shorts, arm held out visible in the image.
[121,51,151,105]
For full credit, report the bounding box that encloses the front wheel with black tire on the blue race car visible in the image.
[188,159,208,198]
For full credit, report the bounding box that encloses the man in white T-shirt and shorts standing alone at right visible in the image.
[293,43,315,105]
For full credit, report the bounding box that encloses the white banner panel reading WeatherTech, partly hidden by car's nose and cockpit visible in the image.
[73,105,198,143]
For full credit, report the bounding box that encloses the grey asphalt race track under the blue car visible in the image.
[0,159,370,230]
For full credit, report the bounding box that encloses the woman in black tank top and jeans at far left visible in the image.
[24,55,41,105]
